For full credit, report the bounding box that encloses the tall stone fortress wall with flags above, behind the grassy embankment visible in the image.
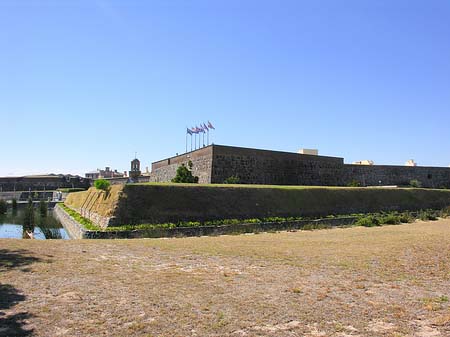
[149,145,450,188]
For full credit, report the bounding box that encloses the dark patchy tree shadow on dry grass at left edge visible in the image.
[0,249,41,337]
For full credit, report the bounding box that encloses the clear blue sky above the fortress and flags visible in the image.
[0,0,450,175]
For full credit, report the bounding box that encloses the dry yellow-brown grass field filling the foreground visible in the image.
[0,219,450,337]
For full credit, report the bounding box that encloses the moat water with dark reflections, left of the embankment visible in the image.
[0,210,70,240]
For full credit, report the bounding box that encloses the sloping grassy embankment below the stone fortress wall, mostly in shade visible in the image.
[62,184,450,230]
